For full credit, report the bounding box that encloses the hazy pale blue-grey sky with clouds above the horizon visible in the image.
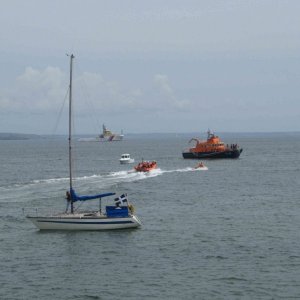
[0,0,300,134]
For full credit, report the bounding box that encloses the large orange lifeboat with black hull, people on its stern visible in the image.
[182,131,243,159]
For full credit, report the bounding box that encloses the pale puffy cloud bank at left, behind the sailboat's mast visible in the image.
[0,67,142,114]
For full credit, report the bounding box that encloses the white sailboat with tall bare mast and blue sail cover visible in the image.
[27,54,141,230]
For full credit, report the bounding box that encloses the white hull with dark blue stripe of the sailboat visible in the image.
[27,215,141,231]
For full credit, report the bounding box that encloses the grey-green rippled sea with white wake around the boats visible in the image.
[0,133,300,300]
